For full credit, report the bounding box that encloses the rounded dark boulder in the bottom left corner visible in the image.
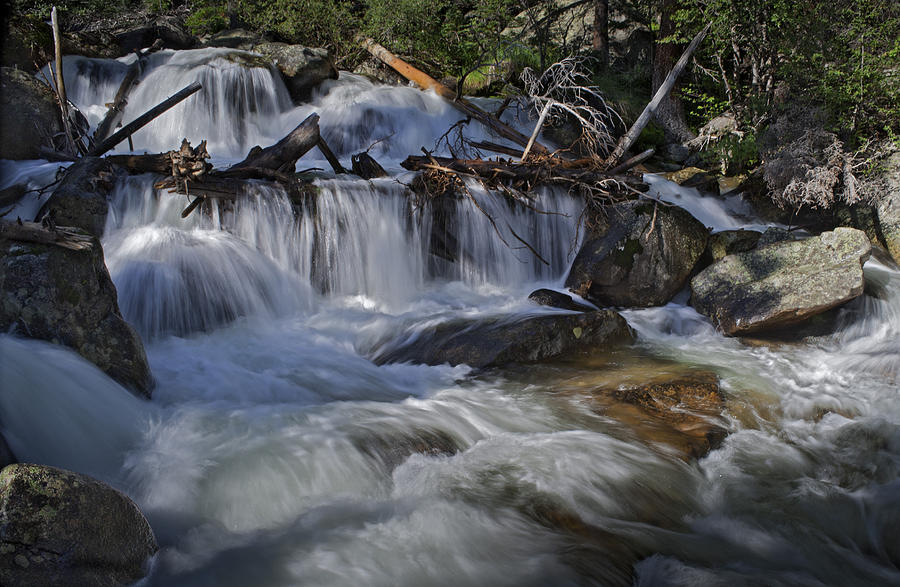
[0,465,159,586]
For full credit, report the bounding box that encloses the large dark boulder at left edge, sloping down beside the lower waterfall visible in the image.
[0,222,153,397]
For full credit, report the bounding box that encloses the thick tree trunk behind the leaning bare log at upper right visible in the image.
[652,0,695,143]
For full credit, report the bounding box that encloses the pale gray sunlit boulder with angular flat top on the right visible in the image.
[691,228,871,336]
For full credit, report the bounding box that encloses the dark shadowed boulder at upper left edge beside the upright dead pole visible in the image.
[0,67,63,159]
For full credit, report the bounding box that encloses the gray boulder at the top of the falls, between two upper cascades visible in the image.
[253,43,338,102]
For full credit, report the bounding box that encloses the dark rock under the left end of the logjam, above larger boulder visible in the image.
[40,157,121,237]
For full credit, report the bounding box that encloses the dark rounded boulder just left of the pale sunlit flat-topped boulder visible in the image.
[566,201,708,307]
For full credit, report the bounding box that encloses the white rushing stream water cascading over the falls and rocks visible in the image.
[0,49,900,586]
